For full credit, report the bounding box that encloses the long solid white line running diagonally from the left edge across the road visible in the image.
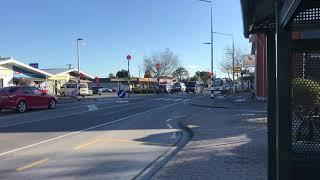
[0,102,180,157]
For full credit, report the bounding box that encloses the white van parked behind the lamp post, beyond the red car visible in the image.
[60,83,93,96]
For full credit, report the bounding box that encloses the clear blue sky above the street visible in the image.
[0,0,250,77]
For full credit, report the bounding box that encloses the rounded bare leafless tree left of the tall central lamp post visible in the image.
[144,49,179,80]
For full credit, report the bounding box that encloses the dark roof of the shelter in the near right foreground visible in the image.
[240,0,320,38]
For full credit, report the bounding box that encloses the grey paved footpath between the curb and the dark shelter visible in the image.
[152,94,267,180]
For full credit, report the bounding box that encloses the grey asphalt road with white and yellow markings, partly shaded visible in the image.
[0,94,201,180]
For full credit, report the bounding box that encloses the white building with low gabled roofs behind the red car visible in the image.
[0,57,94,94]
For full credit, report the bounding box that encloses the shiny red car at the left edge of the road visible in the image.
[0,86,57,113]
